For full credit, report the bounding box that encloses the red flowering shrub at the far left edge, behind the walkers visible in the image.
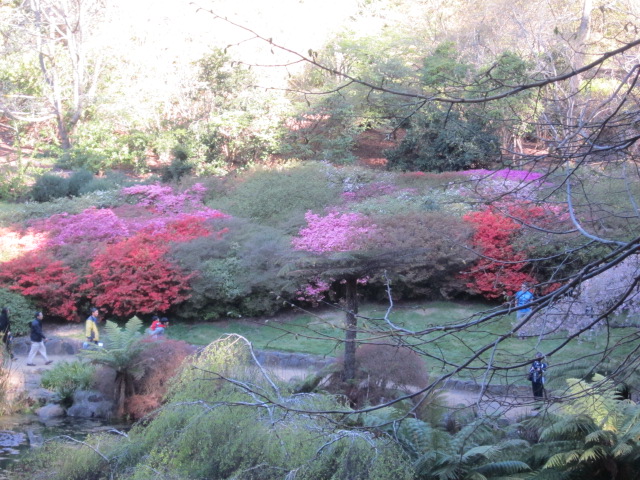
[0,252,79,321]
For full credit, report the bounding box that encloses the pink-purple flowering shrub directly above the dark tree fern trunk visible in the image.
[291,211,376,253]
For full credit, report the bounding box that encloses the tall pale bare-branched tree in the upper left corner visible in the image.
[3,0,105,149]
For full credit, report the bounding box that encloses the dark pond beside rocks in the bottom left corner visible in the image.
[0,415,129,480]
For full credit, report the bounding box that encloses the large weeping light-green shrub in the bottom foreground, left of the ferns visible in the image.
[114,335,413,480]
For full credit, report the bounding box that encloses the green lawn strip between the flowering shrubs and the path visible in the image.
[164,302,635,385]
